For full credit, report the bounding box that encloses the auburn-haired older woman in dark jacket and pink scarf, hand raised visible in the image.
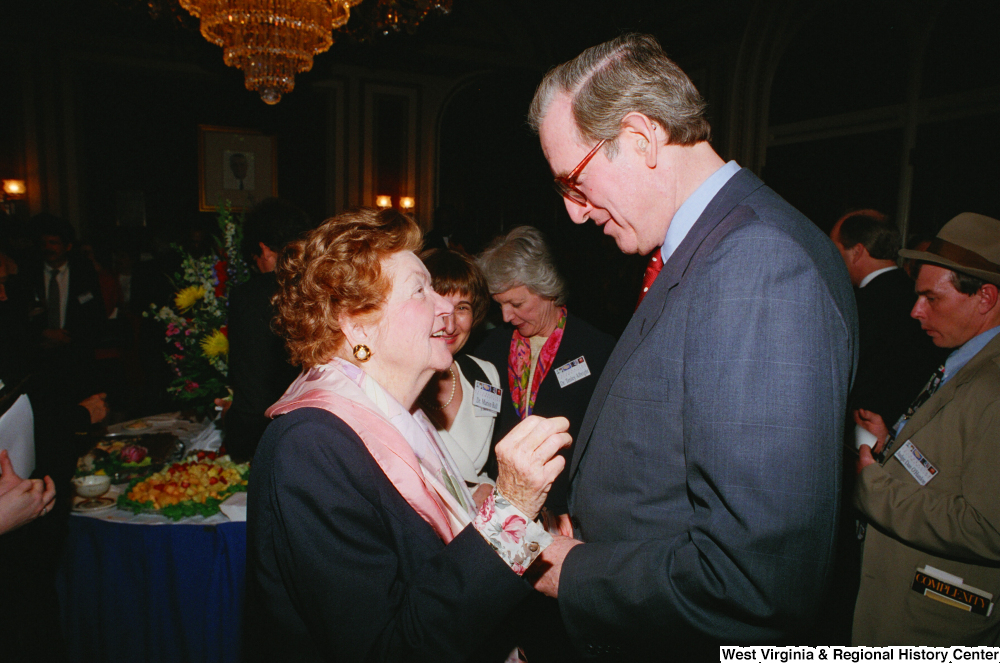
[245,209,569,661]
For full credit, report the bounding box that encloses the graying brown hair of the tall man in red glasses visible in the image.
[528,34,712,157]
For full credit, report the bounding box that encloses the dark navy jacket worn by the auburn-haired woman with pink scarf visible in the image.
[244,408,531,662]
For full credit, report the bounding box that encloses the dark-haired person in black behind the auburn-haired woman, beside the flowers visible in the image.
[225,198,311,462]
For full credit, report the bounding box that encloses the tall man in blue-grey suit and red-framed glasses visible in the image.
[529,35,857,661]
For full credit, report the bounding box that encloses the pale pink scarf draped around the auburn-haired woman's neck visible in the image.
[265,359,474,543]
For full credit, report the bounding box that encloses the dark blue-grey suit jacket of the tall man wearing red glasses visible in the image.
[559,170,857,660]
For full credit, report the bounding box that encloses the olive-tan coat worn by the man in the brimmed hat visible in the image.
[852,336,1000,646]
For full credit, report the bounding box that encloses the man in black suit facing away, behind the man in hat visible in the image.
[830,210,948,422]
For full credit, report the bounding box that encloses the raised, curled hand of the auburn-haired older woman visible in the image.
[496,416,573,518]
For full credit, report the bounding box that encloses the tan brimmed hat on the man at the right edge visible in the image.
[899,212,1000,285]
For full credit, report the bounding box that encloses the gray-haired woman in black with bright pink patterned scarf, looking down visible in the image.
[475,226,615,534]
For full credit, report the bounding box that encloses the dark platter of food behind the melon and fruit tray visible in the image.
[76,433,183,483]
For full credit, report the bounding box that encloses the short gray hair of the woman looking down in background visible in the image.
[476,226,566,306]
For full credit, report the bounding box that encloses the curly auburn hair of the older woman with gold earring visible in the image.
[272,207,423,368]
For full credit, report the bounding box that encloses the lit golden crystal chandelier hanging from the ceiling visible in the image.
[179,0,361,105]
